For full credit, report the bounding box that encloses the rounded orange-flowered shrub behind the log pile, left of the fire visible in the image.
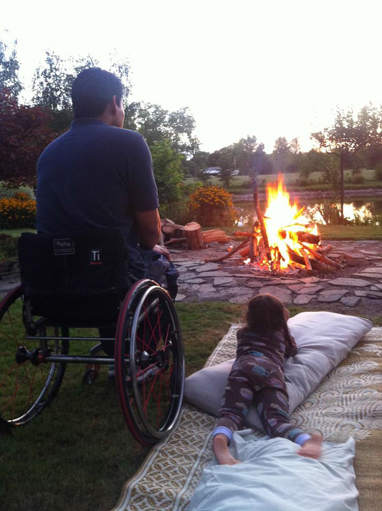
[188,185,236,226]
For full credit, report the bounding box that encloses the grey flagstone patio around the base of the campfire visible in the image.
[172,240,382,314]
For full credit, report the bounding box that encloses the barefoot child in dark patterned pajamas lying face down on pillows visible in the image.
[212,294,322,465]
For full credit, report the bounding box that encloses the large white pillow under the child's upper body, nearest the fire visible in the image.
[184,312,373,430]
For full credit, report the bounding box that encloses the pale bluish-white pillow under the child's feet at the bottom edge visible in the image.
[187,433,358,511]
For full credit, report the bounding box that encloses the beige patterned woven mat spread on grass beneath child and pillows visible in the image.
[112,325,382,511]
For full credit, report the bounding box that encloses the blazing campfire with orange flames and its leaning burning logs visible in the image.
[209,176,342,273]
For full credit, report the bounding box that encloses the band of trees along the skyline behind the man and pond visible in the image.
[0,36,382,219]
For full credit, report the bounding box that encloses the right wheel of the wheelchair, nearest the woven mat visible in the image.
[115,280,185,445]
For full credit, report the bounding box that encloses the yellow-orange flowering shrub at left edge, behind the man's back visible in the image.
[0,196,36,229]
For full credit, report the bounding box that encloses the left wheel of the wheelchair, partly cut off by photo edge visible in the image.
[0,286,68,429]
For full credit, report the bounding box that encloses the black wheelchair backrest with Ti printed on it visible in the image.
[18,229,129,299]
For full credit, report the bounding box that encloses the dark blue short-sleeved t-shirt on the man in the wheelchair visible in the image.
[37,118,159,278]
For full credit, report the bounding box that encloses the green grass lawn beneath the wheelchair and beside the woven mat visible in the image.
[0,303,243,511]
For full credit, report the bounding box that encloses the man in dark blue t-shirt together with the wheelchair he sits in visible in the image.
[0,68,185,445]
